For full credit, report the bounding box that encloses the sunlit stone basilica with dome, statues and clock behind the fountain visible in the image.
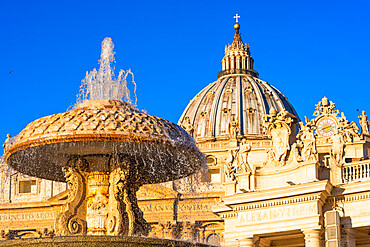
[0,22,370,247]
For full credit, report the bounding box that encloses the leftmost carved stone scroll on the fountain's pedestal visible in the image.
[55,157,88,236]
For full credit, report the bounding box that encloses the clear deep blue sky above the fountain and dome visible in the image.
[0,0,370,149]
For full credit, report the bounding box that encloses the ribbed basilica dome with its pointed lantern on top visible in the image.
[179,24,299,141]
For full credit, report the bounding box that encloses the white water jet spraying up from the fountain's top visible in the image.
[77,37,137,105]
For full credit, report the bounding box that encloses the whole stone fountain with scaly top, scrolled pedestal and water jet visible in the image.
[5,38,205,246]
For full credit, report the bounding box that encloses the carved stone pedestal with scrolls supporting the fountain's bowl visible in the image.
[55,155,150,236]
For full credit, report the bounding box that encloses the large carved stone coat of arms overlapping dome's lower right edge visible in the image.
[264,109,297,166]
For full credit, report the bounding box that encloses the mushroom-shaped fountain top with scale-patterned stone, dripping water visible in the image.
[5,100,204,183]
